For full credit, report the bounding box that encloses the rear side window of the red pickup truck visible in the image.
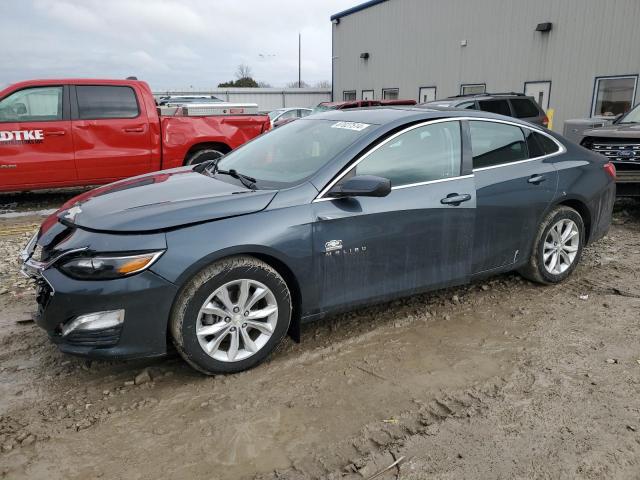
[76,85,140,120]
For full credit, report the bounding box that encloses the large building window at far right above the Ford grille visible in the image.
[591,75,638,117]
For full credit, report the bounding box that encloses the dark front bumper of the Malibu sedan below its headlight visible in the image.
[36,268,177,359]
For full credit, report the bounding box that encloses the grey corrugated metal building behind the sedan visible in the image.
[331,0,640,131]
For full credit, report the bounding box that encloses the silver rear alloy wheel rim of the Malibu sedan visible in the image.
[543,218,580,275]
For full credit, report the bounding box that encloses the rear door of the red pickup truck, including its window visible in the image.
[71,85,156,183]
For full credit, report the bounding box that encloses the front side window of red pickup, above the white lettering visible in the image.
[0,86,63,122]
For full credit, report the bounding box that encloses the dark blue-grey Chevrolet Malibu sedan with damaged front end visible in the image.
[23,108,615,374]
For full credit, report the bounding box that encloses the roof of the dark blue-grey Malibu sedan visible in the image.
[301,106,529,127]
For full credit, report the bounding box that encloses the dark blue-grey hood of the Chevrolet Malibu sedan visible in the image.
[55,167,276,232]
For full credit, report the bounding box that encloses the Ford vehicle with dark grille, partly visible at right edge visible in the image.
[581,104,640,197]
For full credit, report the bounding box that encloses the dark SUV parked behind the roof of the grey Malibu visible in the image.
[420,92,549,127]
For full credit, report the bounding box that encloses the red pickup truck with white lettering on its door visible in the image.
[0,79,271,192]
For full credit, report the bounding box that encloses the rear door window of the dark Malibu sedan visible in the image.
[469,120,528,169]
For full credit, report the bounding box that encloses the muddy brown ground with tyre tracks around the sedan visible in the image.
[0,195,640,479]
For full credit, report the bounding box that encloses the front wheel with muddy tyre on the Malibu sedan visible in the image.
[170,256,292,375]
